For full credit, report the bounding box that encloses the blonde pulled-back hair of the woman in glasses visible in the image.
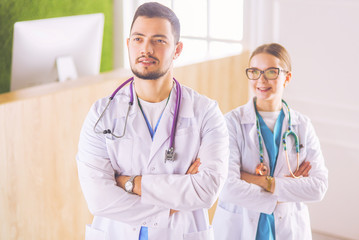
[249,43,292,71]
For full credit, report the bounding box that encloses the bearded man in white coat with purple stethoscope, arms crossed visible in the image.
[77,3,229,240]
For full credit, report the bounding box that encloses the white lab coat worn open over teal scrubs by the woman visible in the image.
[213,100,328,240]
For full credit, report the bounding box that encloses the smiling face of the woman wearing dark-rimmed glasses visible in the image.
[249,53,292,101]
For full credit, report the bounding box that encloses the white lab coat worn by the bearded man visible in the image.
[77,81,229,240]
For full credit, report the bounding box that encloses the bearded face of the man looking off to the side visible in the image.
[127,17,182,80]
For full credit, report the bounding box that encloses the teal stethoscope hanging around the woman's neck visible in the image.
[254,99,300,178]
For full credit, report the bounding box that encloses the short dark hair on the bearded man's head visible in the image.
[131,2,181,43]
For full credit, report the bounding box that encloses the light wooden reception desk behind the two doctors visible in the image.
[0,53,248,240]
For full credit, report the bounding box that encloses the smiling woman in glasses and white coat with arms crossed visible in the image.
[213,43,328,240]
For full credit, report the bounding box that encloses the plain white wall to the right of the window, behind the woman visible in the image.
[246,0,359,239]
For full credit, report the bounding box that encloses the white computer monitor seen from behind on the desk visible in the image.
[11,13,104,91]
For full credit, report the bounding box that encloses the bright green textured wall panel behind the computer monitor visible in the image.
[0,0,113,93]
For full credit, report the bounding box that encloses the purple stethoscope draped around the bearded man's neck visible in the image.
[93,77,182,162]
